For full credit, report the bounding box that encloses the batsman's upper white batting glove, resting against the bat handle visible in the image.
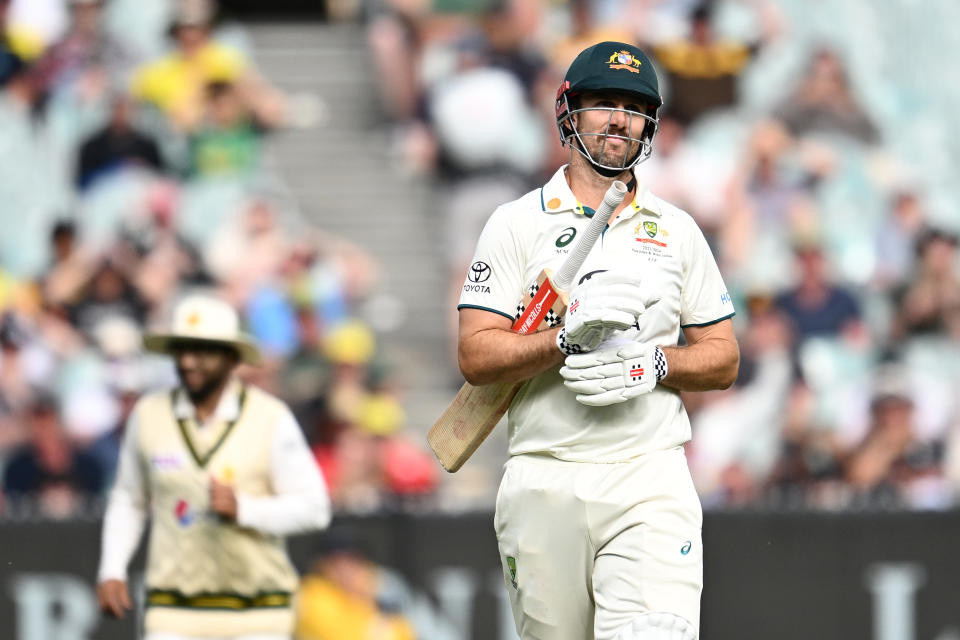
[557,271,660,355]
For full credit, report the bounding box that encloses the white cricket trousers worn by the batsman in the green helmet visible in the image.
[494,447,703,640]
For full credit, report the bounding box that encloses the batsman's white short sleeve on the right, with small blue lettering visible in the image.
[680,220,735,327]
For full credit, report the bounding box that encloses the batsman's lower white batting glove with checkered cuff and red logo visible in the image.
[560,342,667,407]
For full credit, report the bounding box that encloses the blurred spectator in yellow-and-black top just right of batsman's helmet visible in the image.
[651,1,775,125]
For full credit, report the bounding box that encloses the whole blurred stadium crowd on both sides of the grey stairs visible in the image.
[0,0,960,517]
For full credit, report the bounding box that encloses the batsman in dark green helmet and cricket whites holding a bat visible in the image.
[458,42,739,640]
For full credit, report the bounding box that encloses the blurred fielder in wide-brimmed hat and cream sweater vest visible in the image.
[97,295,331,640]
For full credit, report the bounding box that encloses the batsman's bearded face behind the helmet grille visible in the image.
[575,91,647,166]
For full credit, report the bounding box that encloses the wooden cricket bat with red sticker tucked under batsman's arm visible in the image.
[427,180,627,473]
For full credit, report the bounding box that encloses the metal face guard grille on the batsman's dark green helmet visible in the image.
[557,90,658,177]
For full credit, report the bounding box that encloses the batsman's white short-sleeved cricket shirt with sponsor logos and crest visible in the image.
[457,167,734,462]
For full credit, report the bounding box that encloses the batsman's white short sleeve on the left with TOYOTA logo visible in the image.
[457,207,524,320]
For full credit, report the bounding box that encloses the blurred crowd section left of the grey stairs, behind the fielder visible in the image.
[0,0,437,518]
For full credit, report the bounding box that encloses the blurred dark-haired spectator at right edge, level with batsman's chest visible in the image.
[893,227,960,339]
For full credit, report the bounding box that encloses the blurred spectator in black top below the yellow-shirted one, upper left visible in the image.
[76,94,164,190]
